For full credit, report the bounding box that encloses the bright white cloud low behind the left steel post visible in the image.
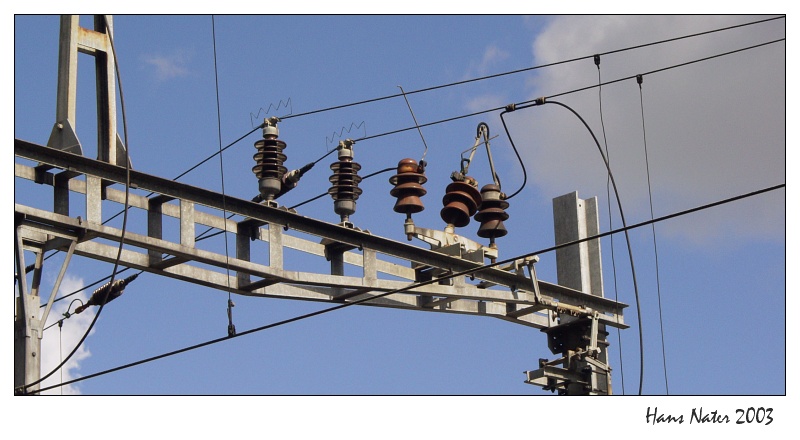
[41,275,95,395]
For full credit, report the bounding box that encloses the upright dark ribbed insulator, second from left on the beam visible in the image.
[328,140,363,223]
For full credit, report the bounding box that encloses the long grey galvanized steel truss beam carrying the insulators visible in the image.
[14,139,627,329]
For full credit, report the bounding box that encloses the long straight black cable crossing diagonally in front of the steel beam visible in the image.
[32,183,786,391]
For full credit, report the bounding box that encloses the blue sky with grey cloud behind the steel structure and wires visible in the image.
[9,15,787,434]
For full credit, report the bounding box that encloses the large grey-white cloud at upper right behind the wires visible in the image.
[506,16,786,243]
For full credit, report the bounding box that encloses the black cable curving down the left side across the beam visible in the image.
[18,16,131,394]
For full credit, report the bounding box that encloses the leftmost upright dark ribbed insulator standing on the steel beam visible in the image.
[253,121,287,202]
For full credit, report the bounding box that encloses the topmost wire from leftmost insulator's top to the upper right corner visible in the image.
[283,15,786,119]
